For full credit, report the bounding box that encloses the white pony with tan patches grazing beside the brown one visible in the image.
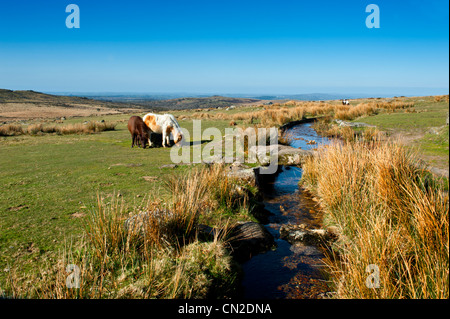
[143,113,183,147]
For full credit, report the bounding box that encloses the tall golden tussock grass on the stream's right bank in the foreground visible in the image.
[301,141,449,298]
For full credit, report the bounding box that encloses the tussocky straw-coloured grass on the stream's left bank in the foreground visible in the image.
[0,166,243,299]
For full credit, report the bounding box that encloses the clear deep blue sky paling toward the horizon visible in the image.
[0,0,449,95]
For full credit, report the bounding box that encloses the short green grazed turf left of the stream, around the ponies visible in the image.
[0,115,232,278]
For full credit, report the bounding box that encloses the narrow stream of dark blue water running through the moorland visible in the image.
[242,123,329,299]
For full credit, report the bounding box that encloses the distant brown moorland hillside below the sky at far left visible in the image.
[0,89,260,122]
